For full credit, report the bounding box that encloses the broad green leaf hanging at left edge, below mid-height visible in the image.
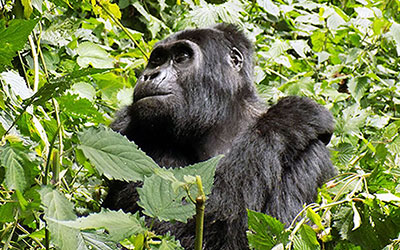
[0,146,28,191]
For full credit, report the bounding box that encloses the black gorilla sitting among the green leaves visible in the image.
[103,24,336,250]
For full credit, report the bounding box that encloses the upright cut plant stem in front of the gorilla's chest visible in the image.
[194,175,206,250]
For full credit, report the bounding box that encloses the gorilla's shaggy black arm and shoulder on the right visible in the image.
[196,97,335,249]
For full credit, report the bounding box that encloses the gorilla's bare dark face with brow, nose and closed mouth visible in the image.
[133,40,202,118]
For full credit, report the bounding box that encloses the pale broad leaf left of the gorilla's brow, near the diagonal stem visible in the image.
[77,42,114,69]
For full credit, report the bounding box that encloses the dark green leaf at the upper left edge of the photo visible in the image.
[0,19,38,70]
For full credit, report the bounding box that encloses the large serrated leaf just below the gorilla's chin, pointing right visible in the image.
[79,127,159,181]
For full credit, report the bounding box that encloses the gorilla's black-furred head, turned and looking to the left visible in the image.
[128,24,257,144]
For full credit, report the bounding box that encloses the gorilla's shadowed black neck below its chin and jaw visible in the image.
[127,100,260,167]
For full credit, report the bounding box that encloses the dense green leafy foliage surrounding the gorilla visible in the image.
[0,0,400,249]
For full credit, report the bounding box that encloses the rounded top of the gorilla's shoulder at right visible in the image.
[255,96,334,146]
